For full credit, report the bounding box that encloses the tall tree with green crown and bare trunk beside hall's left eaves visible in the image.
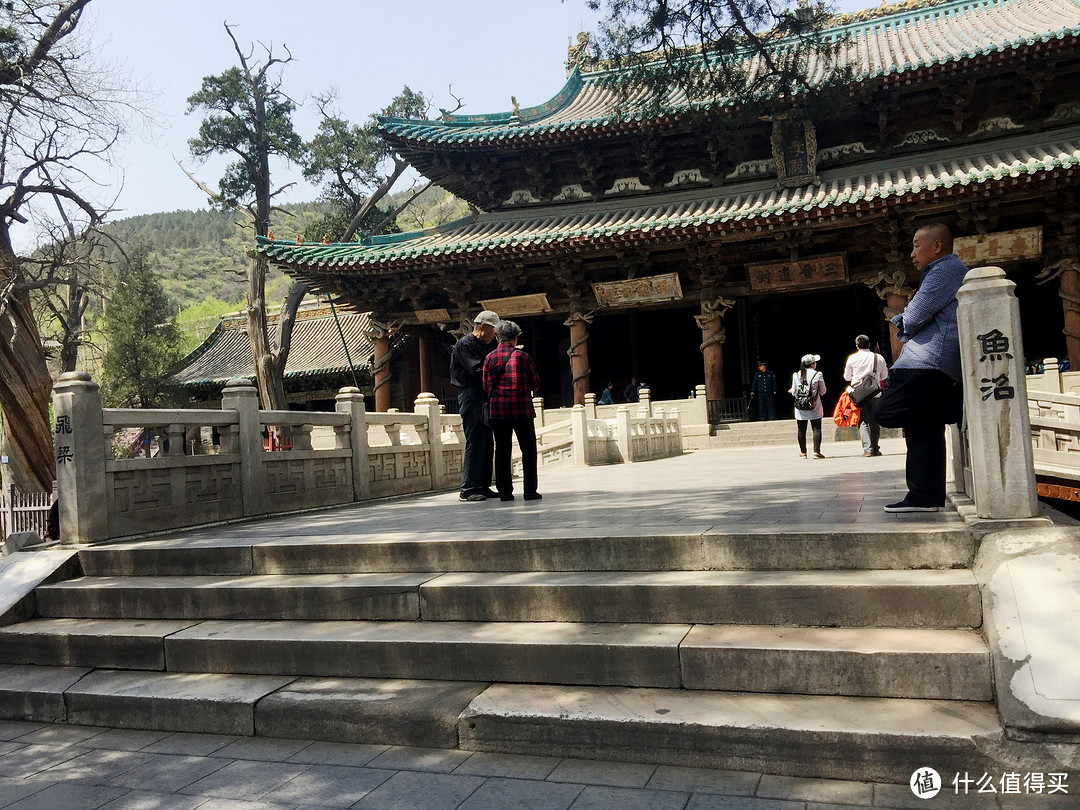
[188,24,303,409]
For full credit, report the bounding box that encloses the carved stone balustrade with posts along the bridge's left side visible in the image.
[53,372,464,543]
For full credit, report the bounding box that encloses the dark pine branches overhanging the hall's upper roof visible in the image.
[578,0,847,114]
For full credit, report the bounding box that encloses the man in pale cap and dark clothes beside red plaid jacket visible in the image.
[450,309,499,501]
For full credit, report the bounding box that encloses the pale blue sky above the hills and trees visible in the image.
[85,0,877,219]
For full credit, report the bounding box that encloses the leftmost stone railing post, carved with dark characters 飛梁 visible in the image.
[53,372,109,543]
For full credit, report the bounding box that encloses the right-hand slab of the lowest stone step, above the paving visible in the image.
[459,684,1003,783]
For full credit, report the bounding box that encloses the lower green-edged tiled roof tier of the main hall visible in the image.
[258,129,1080,275]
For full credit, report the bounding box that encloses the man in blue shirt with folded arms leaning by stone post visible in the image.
[874,222,968,512]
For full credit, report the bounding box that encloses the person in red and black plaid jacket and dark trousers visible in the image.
[484,321,541,501]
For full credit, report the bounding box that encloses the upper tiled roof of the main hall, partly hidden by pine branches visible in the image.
[381,0,1080,145]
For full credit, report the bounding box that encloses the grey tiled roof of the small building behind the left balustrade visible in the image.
[168,308,384,387]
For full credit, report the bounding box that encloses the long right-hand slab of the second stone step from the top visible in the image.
[420,569,982,627]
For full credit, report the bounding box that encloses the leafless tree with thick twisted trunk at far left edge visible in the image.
[0,0,132,490]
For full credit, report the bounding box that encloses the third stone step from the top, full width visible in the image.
[0,619,990,700]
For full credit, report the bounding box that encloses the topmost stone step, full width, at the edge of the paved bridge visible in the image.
[79,525,975,576]
